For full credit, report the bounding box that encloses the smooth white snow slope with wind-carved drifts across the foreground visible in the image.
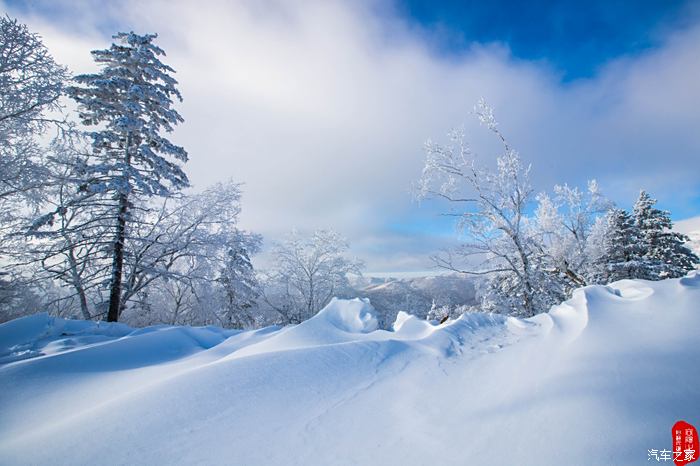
[0,274,700,465]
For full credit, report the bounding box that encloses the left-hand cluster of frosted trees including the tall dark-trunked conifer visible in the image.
[0,17,359,328]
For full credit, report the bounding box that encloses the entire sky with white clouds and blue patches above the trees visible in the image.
[5,0,700,272]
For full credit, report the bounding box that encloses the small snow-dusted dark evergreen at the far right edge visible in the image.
[633,191,700,280]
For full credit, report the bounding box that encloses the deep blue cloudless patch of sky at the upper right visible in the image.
[396,0,697,81]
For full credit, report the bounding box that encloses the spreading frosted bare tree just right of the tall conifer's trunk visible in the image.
[121,181,261,326]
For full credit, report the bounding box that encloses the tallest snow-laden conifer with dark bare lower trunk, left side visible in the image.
[68,32,188,321]
